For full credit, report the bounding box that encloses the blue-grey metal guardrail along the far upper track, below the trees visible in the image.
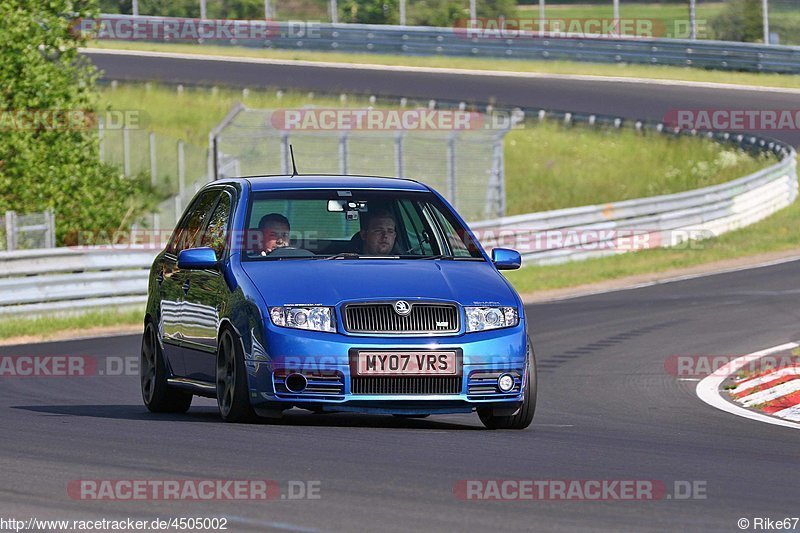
[86,14,800,74]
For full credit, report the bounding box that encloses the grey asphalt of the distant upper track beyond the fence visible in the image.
[86,49,800,146]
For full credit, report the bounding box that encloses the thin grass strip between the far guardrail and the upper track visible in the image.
[91,41,800,89]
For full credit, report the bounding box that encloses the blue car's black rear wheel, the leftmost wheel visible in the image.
[139,321,192,413]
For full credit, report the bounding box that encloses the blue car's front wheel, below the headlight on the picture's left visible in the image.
[217,329,257,422]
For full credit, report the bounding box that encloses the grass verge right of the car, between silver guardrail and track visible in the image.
[507,191,800,293]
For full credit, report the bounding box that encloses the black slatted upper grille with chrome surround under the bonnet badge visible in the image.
[344,302,459,334]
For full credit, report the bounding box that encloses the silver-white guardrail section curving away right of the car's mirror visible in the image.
[470,151,798,265]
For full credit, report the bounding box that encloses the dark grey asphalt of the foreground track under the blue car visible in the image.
[0,262,800,531]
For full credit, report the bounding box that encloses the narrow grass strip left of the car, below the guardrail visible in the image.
[0,309,144,339]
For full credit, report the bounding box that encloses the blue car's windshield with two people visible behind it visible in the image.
[243,190,483,260]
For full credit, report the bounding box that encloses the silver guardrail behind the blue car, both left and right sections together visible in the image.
[0,101,798,319]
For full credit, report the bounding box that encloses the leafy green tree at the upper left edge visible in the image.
[0,0,155,244]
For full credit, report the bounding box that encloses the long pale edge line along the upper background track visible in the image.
[80,48,800,95]
